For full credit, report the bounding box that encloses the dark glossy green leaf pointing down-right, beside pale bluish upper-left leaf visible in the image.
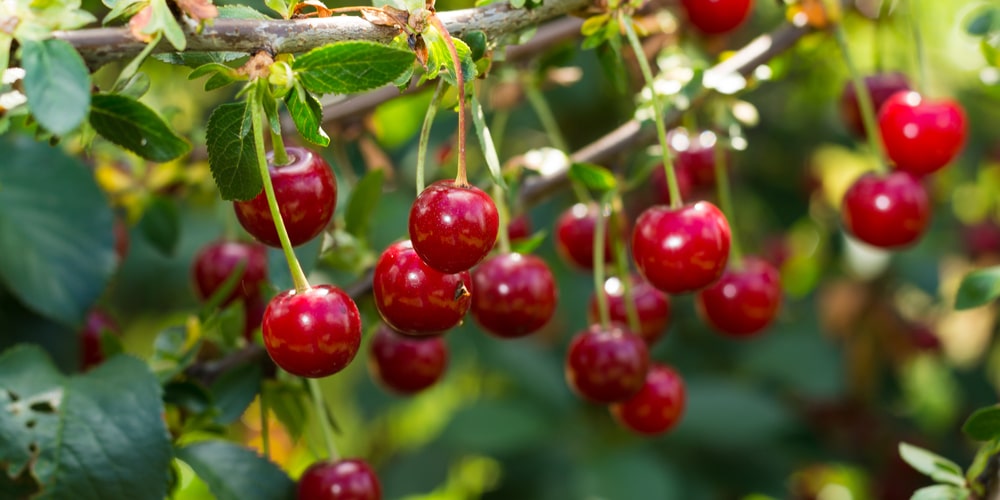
[90,94,191,162]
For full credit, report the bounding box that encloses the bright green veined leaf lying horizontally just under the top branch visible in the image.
[292,41,414,94]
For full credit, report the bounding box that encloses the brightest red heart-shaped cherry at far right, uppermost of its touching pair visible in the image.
[878,91,967,176]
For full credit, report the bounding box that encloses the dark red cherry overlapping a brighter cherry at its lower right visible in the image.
[566,324,649,403]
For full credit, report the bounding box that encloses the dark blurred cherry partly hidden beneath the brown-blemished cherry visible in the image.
[368,324,448,394]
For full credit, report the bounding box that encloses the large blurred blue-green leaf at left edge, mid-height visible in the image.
[0,134,117,327]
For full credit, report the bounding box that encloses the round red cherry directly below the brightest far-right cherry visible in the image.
[841,171,931,249]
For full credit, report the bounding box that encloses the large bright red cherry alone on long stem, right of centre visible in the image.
[632,201,730,294]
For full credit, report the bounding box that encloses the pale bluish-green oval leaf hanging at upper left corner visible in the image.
[21,39,90,135]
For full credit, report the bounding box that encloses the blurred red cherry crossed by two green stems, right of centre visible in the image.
[587,276,670,346]
